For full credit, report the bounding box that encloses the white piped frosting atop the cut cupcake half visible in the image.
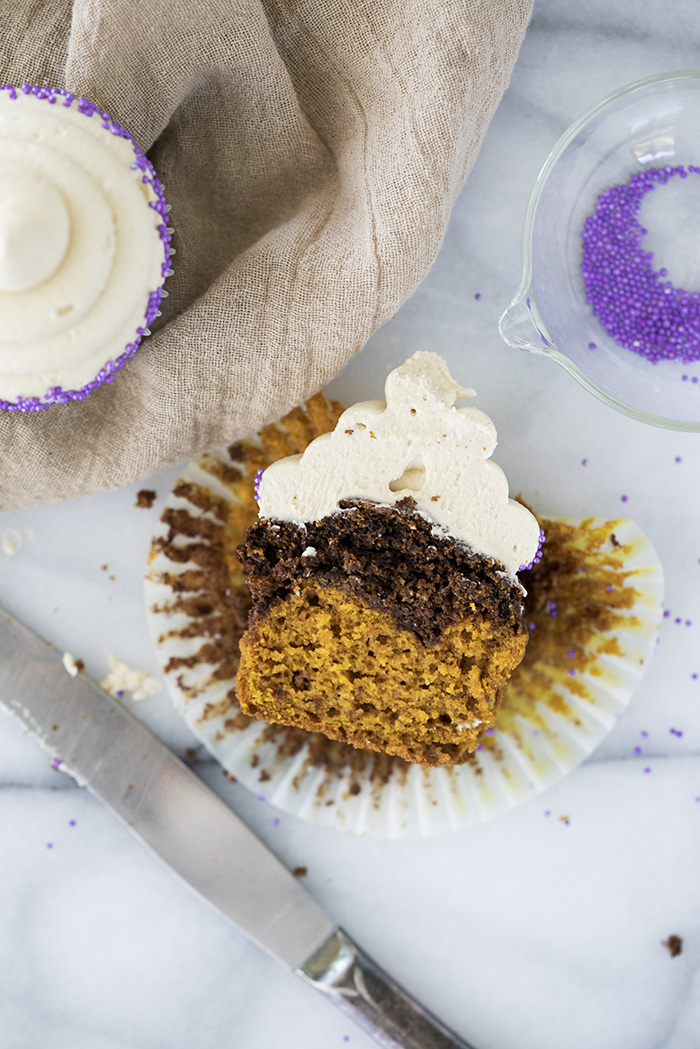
[258,352,539,576]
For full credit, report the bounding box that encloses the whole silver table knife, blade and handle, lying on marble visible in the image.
[0,611,473,1049]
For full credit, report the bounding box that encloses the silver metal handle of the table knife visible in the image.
[295,928,474,1049]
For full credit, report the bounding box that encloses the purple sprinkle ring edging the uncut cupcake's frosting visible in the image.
[0,84,172,412]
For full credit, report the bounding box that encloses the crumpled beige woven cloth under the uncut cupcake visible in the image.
[0,0,532,510]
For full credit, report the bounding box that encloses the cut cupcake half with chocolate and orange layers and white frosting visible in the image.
[236,354,540,765]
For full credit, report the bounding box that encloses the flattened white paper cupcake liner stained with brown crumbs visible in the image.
[146,443,663,838]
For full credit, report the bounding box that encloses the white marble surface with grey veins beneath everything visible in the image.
[0,0,700,1049]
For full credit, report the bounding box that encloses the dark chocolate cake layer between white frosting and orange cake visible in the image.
[237,497,525,645]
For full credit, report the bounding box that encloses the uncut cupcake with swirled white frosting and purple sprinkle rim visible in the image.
[0,84,172,411]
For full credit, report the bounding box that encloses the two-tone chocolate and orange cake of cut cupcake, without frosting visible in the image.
[237,497,527,765]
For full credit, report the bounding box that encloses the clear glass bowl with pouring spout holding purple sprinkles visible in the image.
[499,69,700,431]
